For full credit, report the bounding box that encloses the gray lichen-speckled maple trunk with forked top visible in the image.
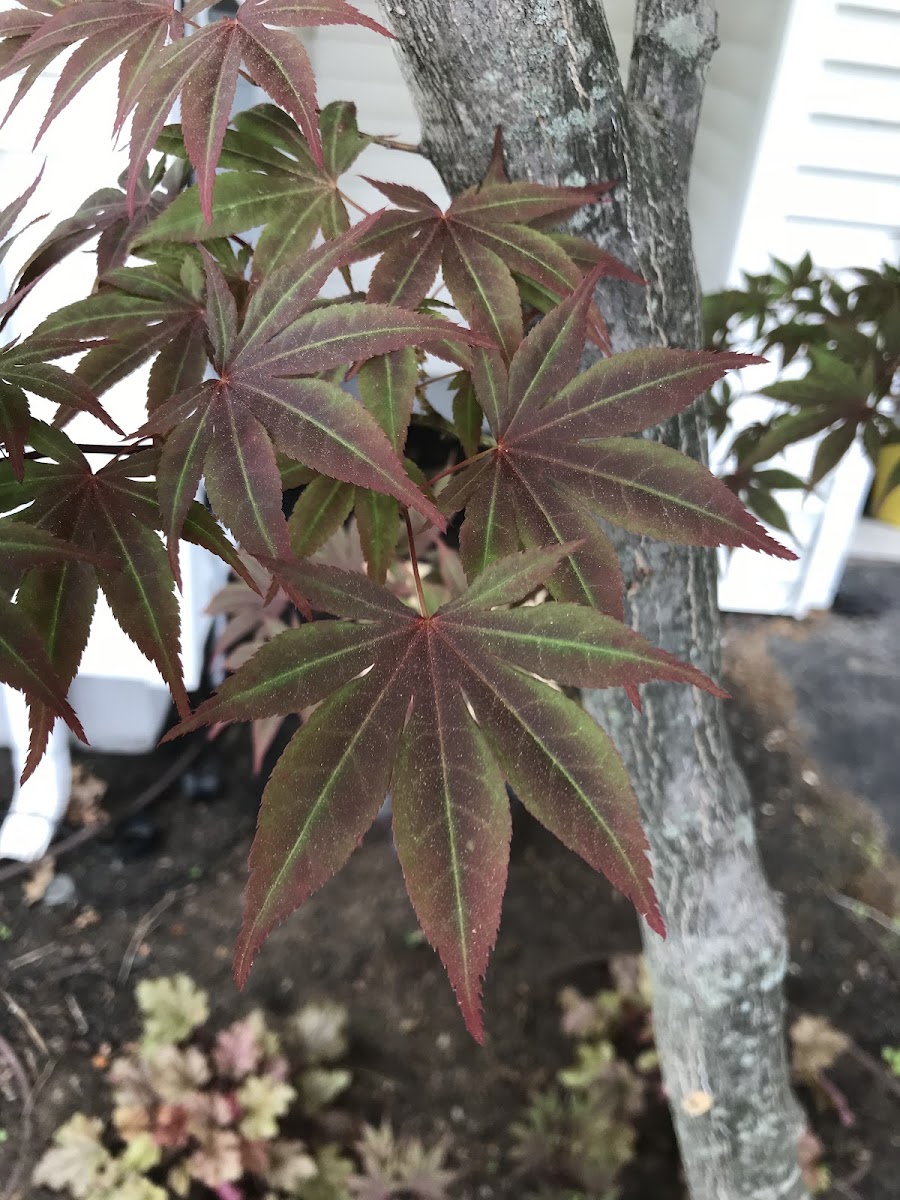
[382,0,806,1200]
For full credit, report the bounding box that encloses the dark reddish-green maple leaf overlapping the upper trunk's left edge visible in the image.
[345,132,638,359]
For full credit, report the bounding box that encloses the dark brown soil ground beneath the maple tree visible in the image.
[0,609,900,1200]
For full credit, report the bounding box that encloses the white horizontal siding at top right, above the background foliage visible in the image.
[731,0,900,276]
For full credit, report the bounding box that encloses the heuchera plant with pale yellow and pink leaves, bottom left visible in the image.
[34,974,451,1200]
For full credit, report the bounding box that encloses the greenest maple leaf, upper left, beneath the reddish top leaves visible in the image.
[144,101,371,276]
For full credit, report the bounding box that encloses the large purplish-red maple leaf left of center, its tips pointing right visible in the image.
[139,224,484,571]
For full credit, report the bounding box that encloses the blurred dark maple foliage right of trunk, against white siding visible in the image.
[703,254,900,532]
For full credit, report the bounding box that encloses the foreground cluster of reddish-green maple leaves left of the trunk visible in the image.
[0,0,791,1038]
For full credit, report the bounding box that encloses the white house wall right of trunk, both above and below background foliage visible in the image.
[719,0,900,616]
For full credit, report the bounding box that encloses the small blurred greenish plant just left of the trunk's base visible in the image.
[511,955,656,1200]
